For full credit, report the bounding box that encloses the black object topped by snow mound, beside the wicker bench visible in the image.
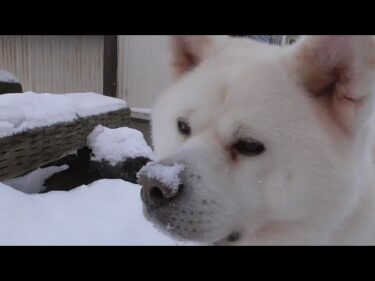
[41,125,154,192]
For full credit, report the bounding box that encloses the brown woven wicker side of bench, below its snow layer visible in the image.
[0,108,130,181]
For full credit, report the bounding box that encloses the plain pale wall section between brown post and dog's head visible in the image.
[117,35,171,108]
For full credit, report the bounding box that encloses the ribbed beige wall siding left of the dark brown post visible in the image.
[0,35,104,93]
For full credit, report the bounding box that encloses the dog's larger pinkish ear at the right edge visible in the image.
[293,36,375,130]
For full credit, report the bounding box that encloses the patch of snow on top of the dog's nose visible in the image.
[137,162,185,192]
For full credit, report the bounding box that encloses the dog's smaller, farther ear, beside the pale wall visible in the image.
[171,35,226,78]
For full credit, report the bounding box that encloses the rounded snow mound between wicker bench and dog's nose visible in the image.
[87,125,154,165]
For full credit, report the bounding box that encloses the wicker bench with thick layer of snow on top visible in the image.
[0,92,130,180]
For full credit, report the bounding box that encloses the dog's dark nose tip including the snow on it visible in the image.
[137,162,184,208]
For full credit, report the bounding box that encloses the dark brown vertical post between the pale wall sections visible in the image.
[103,35,118,97]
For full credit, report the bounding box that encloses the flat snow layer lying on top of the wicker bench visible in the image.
[0,92,127,137]
